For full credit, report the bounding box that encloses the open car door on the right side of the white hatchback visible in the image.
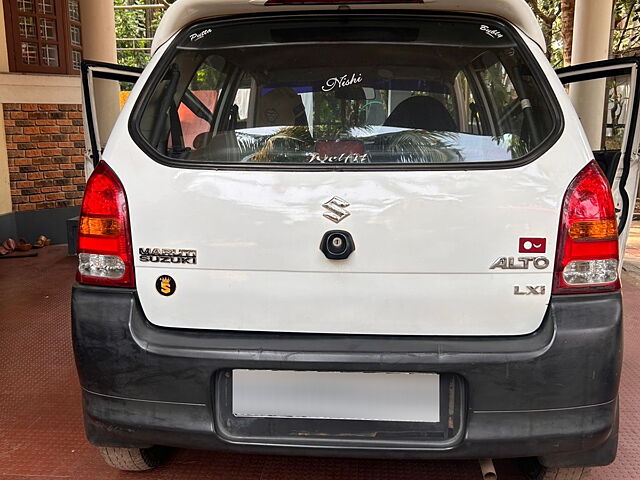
[558,57,640,261]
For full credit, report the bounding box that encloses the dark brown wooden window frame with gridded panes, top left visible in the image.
[2,0,82,75]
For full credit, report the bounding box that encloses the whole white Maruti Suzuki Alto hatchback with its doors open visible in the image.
[73,0,640,478]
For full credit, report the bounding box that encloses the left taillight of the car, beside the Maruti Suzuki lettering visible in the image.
[77,162,135,287]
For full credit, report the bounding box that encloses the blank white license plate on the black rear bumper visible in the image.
[232,370,440,423]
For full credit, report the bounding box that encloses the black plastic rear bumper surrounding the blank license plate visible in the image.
[73,286,622,464]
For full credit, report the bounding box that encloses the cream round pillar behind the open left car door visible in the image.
[80,0,120,152]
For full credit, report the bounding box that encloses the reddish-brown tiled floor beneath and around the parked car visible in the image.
[0,246,640,480]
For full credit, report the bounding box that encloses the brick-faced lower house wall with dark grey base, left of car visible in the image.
[0,101,85,243]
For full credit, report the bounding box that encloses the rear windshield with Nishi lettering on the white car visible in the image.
[137,15,554,167]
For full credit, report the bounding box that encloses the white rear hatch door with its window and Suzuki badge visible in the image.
[105,14,572,336]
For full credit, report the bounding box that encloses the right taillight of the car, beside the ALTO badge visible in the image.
[553,161,620,294]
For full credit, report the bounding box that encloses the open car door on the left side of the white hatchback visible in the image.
[81,60,142,178]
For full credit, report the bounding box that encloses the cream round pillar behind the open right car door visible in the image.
[569,0,613,150]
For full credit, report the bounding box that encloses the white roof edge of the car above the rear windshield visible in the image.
[151,0,546,53]
